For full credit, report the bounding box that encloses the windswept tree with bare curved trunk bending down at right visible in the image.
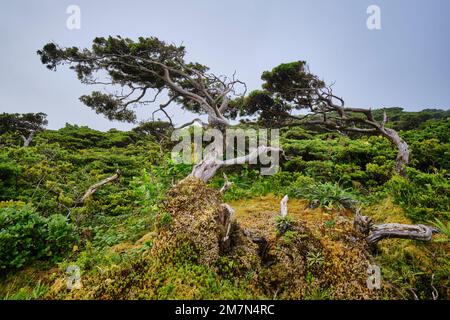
[240,61,409,175]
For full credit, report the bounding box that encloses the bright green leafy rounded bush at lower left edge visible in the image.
[0,202,76,270]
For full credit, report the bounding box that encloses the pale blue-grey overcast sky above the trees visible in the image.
[0,0,450,130]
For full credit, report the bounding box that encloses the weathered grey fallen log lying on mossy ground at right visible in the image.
[353,210,439,246]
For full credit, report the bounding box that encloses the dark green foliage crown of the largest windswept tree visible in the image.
[37,36,214,122]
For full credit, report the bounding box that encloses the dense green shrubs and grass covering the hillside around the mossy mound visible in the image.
[0,108,450,299]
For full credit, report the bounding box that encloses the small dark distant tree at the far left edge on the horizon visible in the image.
[0,112,48,147]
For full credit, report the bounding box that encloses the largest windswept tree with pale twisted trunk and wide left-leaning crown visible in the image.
[37,36,280,181]
